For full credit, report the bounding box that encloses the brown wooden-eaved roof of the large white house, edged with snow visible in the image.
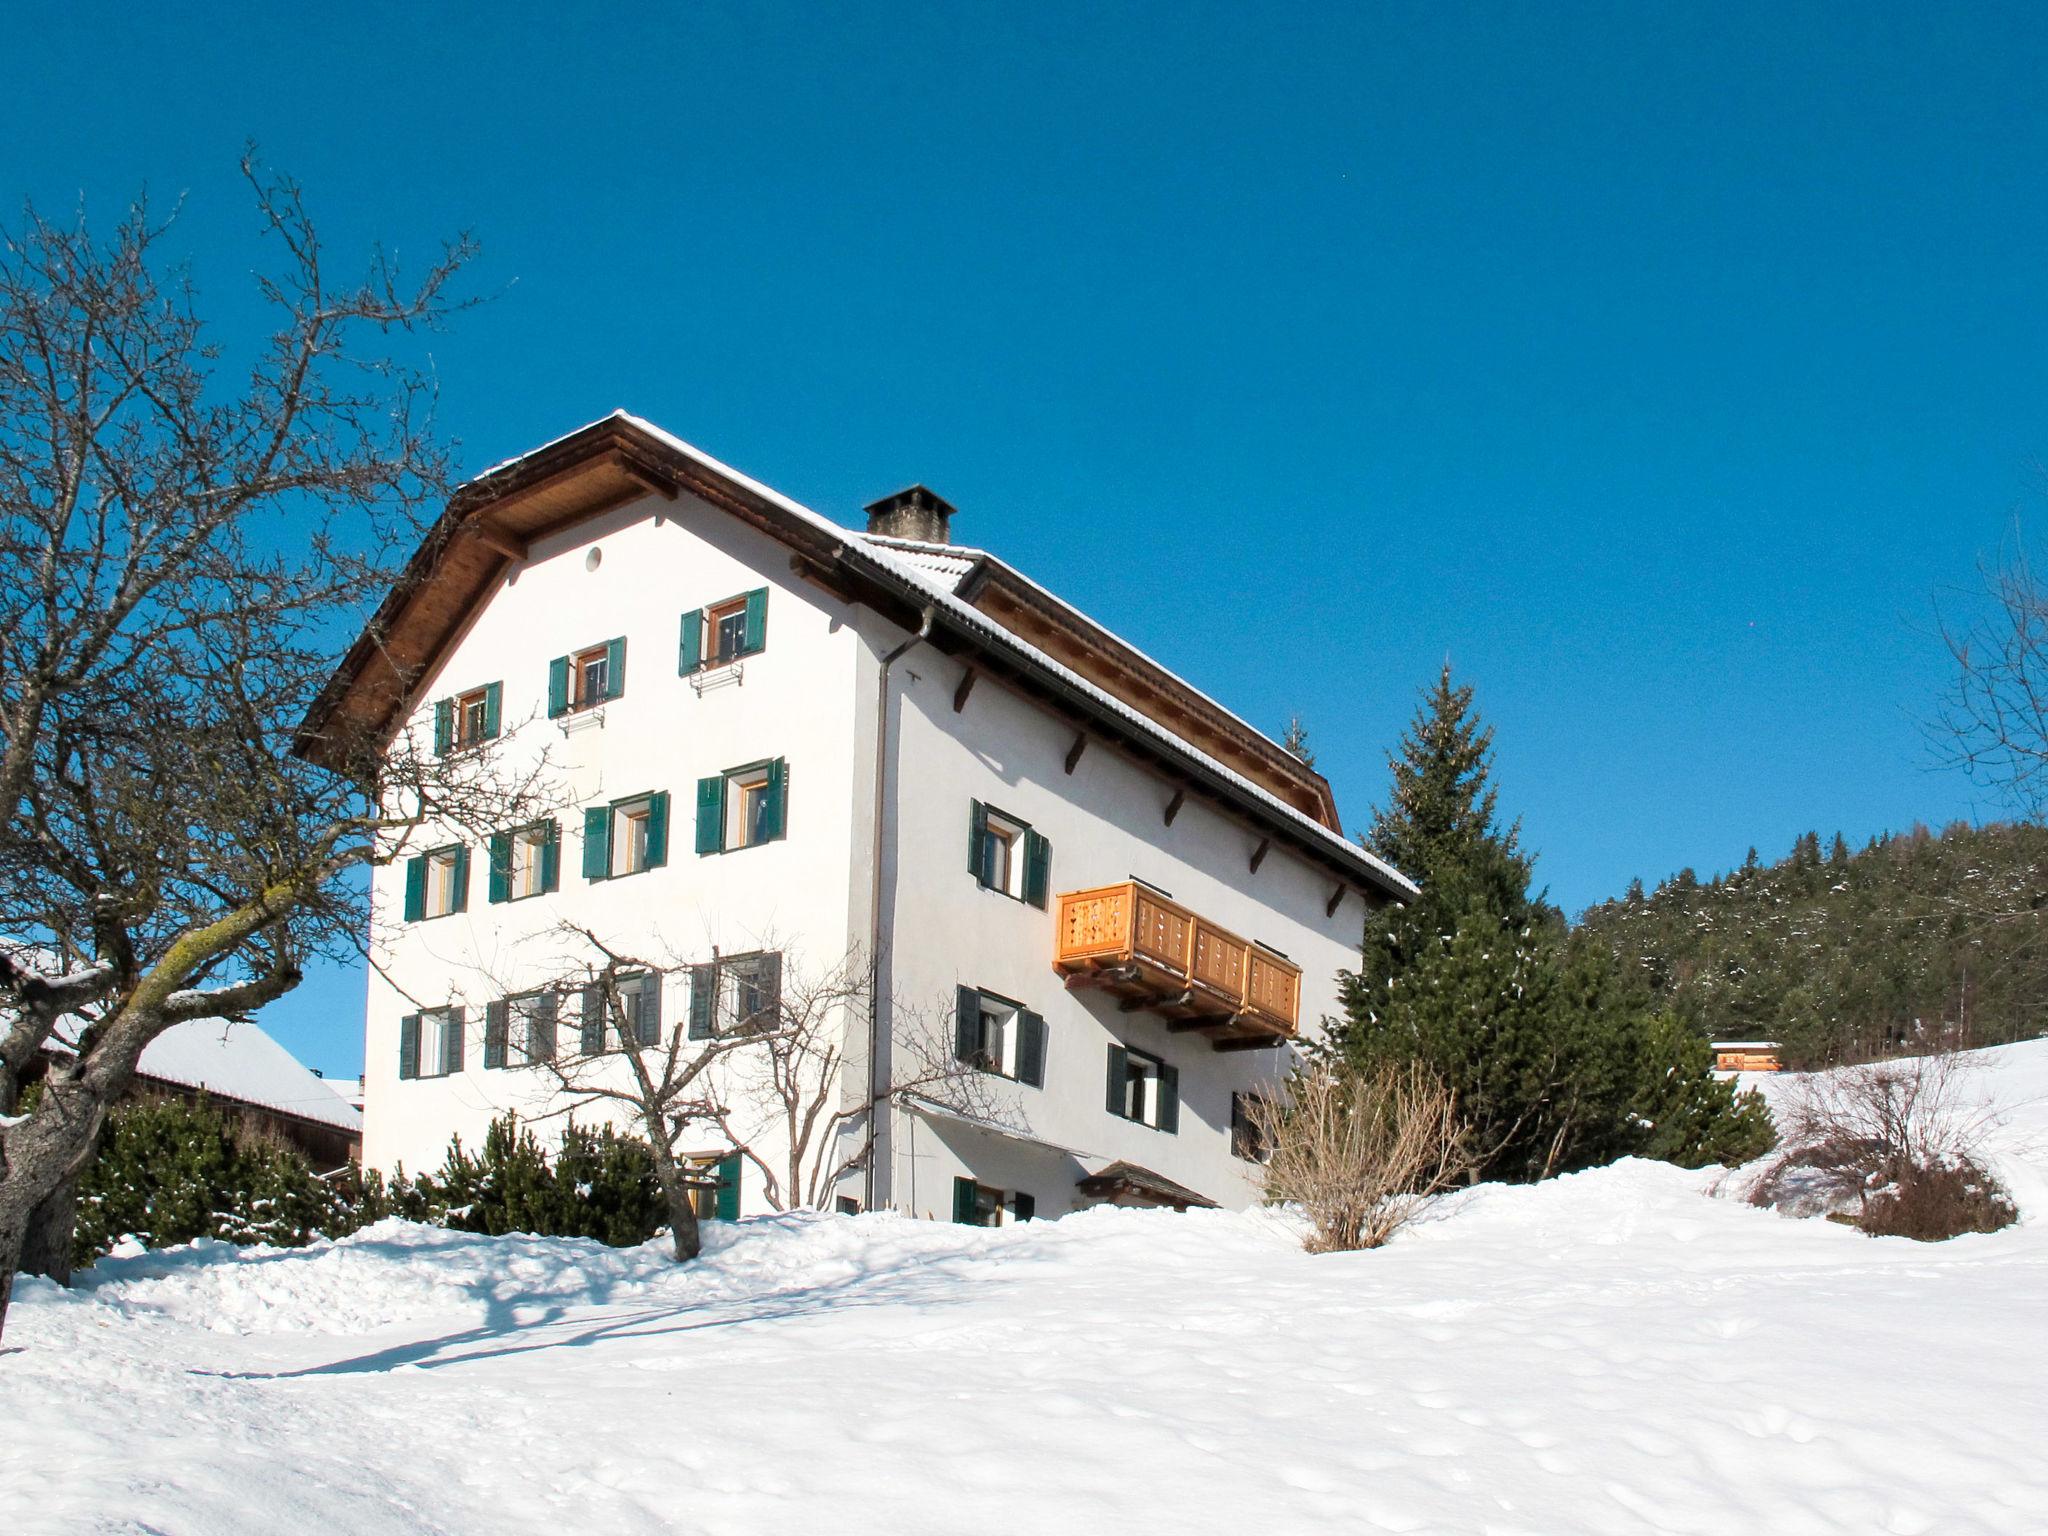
[297,412,1417,899]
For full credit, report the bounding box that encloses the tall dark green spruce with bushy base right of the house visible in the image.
[1331,668,1769,1180]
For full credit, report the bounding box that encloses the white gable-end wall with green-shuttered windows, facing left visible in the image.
[362,498,868,1210]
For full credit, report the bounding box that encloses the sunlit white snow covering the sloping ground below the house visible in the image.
[0,1042,2048,1536]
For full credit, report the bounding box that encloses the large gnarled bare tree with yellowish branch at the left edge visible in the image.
[0,164,532,1323]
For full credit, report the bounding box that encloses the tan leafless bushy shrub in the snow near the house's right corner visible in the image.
[1249,1061,1473,1253]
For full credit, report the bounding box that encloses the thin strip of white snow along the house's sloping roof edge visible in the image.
[602,410,1421,909]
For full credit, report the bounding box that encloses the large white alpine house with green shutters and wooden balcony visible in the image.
[301,412,1415,1225]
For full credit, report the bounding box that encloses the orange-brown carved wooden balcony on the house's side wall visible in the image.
[1053,881,1300,1051]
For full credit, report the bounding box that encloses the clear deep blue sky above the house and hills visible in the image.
[0,4,2048,1071]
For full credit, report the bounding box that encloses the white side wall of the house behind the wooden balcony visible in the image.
[889,647,1364,1219]
